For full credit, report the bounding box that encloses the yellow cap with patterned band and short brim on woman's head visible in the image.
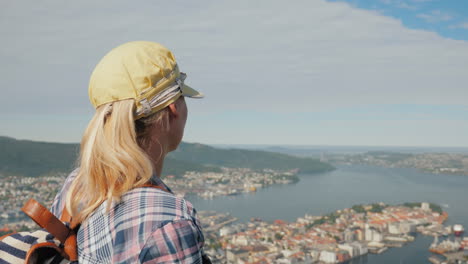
[88,41,203,119]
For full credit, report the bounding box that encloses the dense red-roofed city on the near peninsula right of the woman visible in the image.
[202,203,468,263]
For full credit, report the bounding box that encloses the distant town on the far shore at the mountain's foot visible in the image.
[0,168,299,232]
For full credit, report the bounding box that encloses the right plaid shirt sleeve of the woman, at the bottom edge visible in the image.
[139,220,204,264]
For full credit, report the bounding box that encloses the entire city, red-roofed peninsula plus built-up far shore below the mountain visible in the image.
[0,168,468,263]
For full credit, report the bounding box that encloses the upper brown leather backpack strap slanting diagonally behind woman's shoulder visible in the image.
[21,198,70,243]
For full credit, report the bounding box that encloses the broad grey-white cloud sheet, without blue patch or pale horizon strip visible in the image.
[0,0,468,144]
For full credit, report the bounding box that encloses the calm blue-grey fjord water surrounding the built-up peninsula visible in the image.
[188,165,468,264]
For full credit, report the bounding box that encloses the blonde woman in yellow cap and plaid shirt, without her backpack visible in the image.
[52,41,204,263]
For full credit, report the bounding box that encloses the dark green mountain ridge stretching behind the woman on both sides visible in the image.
[0,136,334,177]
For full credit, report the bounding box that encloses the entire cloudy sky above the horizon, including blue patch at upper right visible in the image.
[0,0,468,147]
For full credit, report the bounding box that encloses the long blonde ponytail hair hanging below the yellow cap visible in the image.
[66,99,169,222]
